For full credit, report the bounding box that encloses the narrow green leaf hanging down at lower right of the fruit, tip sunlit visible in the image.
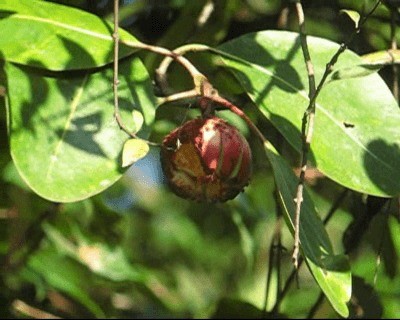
[265,143,351,317]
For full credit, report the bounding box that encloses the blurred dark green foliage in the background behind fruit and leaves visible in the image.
[0,0,400,318]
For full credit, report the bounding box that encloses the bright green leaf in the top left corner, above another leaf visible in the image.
[0,0,138,70]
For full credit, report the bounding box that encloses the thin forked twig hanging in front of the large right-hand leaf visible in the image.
[292,0,381,267]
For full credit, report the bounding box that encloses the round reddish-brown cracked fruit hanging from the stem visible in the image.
[161,116,252,202]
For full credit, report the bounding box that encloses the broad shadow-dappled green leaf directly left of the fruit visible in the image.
[6,58,155,202]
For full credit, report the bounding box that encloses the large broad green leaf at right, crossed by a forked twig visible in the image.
[219,31,400,196]
